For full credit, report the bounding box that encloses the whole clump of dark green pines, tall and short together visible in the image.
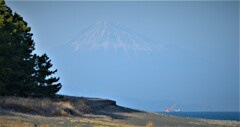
[0,0,61,97]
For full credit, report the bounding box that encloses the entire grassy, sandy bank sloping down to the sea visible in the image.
[0,96,240,127]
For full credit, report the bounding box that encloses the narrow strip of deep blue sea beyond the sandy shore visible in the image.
[159,112,240,121]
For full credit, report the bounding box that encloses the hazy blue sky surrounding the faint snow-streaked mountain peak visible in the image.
[7,1,239,111]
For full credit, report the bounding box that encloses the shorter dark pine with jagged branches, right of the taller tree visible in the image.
[35,54,62,96]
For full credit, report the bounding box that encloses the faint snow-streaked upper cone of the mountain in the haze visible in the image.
[70,21,164,54]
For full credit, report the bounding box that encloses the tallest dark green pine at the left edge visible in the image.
[0,0,35,96]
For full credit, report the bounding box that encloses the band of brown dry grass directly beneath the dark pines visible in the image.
[0,97,91,116]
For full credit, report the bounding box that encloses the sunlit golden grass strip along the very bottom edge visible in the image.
[0,117,154,127]
